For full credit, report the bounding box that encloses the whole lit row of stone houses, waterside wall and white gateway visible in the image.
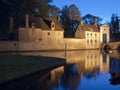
[0,15,109,51]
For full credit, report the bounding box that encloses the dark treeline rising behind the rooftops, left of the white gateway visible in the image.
[0,0,102,37]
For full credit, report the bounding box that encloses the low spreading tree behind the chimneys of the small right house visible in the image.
[82,14,102,26]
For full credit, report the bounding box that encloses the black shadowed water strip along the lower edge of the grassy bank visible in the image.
[0,65,63,90]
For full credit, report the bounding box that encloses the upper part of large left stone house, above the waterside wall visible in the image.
[16,15,64,41]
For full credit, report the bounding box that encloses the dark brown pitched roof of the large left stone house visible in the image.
[20,16,63,31]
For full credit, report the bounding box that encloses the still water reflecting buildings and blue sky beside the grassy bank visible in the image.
[0,50,120,90]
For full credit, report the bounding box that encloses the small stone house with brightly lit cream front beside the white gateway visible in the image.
[75,19,100,49]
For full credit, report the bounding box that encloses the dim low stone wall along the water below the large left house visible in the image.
[0,41,64,52]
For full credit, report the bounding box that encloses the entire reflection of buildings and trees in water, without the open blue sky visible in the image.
[17,50,120,90]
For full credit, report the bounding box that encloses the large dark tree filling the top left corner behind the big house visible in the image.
[0,0,53,36]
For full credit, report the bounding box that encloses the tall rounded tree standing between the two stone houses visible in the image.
[61,4,80,37]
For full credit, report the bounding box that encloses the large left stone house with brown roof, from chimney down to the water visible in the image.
[10,15,64,49]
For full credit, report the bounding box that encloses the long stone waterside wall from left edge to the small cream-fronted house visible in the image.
[0,37,100,51]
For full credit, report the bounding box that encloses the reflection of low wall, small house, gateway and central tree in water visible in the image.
[51,50,109,90]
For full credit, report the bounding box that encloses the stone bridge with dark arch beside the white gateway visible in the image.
[101,42,120,50]
